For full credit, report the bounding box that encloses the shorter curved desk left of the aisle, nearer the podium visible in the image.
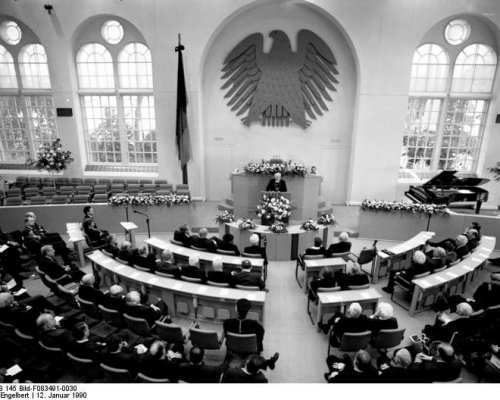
[144,237,264,272]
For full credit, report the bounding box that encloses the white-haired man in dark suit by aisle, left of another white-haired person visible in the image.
[318,303,369,347]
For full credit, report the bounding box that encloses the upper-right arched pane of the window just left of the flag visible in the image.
[118,43,153,89]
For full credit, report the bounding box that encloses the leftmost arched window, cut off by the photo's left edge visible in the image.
[0,20,58,164]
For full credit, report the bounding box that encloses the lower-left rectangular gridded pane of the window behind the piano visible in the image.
[400,98,442,170]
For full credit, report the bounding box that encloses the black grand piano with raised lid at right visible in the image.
[405,171,489,214]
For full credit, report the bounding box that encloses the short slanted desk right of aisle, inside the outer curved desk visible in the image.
[370,231,434,283]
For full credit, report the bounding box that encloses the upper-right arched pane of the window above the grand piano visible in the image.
[451,44,497,93]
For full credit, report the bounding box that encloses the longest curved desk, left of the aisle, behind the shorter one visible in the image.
[87,250,266,323]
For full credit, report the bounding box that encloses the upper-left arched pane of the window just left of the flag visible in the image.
[76,43,115,89]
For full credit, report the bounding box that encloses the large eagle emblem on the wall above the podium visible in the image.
[222,29,338,129]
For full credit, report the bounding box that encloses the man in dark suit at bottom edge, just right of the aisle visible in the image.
[325,350,378,383]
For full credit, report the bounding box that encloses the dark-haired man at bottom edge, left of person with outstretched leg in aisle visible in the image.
[179,346,224,383]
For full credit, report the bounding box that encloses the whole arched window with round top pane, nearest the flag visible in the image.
[76,20,158,166]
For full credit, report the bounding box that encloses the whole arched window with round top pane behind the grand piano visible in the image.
[400,19,497,174]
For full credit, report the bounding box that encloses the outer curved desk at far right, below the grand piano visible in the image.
[409,236,496,315]
